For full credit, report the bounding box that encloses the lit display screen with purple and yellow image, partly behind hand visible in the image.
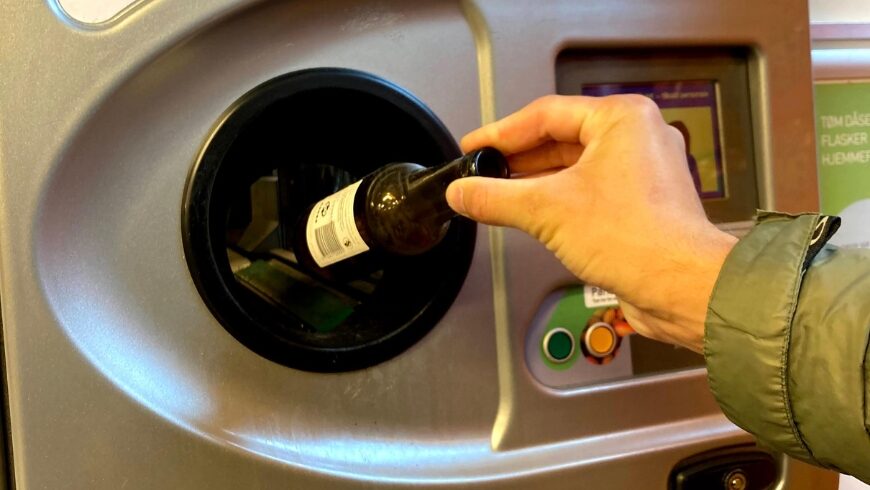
[581,80,726,199]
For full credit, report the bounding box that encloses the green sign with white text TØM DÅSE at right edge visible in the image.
[815,81,870,247]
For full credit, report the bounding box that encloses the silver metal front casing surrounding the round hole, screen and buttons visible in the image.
[0,0,831,489]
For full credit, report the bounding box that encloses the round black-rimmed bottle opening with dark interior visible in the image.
[182,68,476,372]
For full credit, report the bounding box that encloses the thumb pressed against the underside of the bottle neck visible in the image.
[447,177,536,229]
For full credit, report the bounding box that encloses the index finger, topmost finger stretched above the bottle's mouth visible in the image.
[462,95,601,155]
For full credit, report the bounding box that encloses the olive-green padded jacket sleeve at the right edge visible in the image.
[704,213,870,481]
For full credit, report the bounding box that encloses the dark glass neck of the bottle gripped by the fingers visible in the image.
[408,148,510,223]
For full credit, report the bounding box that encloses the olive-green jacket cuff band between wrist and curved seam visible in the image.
[704,213,839,464]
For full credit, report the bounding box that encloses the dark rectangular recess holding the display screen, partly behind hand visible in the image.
[556,48,759,223]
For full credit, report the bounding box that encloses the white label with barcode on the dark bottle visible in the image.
[305,181,369,267]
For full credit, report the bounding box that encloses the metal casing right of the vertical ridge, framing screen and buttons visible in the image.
[478,0,818,454]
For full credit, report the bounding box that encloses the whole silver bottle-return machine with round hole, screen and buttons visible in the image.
[0,0,836,490]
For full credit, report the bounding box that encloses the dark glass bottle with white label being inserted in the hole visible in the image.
[294,148,510,268]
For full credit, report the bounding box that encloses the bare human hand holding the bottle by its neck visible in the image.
[447,95,736,352]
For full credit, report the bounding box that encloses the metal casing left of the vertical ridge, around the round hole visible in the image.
[2,1,497,488]
